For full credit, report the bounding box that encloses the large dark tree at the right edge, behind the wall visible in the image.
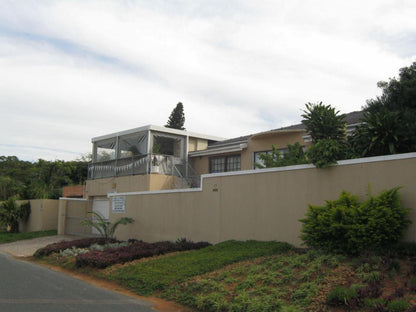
[351,62,416,156]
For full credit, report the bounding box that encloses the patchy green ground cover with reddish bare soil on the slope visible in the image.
[163,251,341,311]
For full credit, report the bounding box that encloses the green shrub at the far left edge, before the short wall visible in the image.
[0,197,30,233]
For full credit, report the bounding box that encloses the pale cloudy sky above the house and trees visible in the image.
[0,0,416,161]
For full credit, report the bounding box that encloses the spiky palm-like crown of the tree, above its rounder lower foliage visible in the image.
[302,102,346,143]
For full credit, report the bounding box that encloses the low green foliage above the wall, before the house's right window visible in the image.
[255,142,308,168]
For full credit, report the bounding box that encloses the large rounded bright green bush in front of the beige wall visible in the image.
[300,187,411,255]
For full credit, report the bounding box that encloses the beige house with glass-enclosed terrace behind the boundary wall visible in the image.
[86,112,362,198]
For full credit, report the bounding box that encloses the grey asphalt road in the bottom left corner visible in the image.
[0,252,155,312]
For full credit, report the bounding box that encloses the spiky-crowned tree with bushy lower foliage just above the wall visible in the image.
[302,102,349,168]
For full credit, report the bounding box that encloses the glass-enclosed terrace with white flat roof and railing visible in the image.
[88,125,218,187]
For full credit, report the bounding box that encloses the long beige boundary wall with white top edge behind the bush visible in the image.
[110,154,416,245]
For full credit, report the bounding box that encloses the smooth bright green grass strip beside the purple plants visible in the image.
[106,241,292,295]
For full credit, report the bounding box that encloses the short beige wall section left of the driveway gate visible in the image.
[18,199,59,232]
